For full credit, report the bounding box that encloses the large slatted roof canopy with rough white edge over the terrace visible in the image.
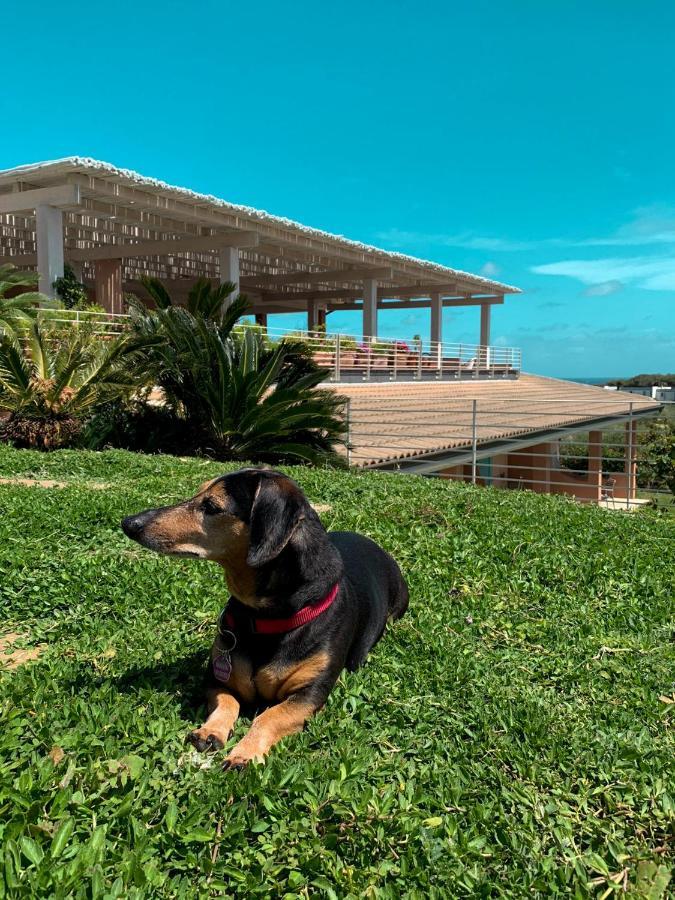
[0,157,520,312]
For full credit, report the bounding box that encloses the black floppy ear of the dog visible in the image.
[246,475,304,568]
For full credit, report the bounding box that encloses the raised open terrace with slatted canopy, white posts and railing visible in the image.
[0,157,520,368]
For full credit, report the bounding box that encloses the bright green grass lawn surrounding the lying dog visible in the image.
[0,447,675,900]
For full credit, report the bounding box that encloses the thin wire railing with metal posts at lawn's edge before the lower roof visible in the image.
[347,396,675,515]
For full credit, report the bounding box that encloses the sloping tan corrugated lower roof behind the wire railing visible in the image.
[335,375,659,467]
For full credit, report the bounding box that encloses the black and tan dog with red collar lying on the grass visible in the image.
[122,468,408,768]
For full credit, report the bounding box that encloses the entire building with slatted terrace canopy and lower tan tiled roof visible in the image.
[0,157,661,504]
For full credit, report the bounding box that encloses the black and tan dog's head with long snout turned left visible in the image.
[122,469,308,569]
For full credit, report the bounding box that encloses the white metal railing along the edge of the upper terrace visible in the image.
[34,309,522,382]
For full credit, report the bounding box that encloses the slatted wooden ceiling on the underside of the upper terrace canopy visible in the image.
[0,157,517,293]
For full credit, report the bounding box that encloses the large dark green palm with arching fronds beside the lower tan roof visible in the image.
[130,279,346,466]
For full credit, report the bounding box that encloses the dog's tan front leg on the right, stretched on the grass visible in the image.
[223,691,318,769]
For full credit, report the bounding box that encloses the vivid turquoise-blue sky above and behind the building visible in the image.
[0,0,675,376]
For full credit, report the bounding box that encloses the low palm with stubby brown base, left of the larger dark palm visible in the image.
[0,321,141,450]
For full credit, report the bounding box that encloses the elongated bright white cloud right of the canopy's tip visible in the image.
[530,256,675,291]
